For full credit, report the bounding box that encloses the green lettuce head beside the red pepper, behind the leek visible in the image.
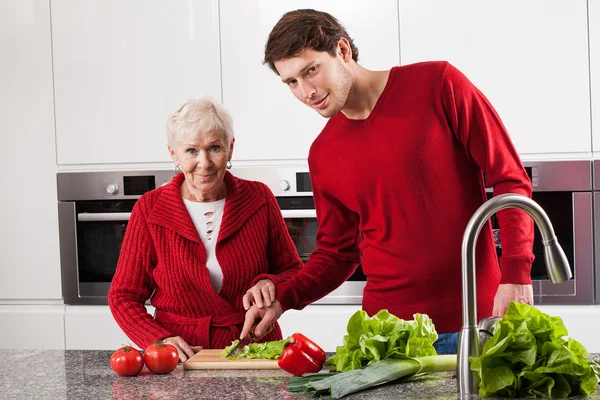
[326,310,438,372]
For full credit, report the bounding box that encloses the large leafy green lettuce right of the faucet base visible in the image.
[469,302,600,398]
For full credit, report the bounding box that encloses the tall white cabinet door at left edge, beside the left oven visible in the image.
[0,0,62,300]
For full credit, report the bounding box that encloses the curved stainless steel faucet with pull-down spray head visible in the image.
[456,194,572,397]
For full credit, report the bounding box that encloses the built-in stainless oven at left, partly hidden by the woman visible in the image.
[57,170,173,304]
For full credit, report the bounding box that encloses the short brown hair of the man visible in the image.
[263,9,358,75]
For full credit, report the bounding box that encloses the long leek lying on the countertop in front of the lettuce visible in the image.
[288,355,456,399]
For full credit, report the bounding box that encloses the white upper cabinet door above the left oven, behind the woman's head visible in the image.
[52,0,221,164]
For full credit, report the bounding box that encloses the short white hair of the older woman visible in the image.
[167,97,233,148]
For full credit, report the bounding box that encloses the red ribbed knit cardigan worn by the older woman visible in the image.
[108,172,302,349]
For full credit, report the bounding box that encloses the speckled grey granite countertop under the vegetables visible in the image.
[0,350,600,400]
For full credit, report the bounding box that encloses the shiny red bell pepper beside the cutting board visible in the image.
[277,333,327,376]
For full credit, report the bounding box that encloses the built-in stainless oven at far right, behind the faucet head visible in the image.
[488,160,595,304]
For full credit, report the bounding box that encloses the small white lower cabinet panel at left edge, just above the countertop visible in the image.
[0,305,65,349]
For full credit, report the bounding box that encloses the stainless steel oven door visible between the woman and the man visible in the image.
[281,209,366,304]
